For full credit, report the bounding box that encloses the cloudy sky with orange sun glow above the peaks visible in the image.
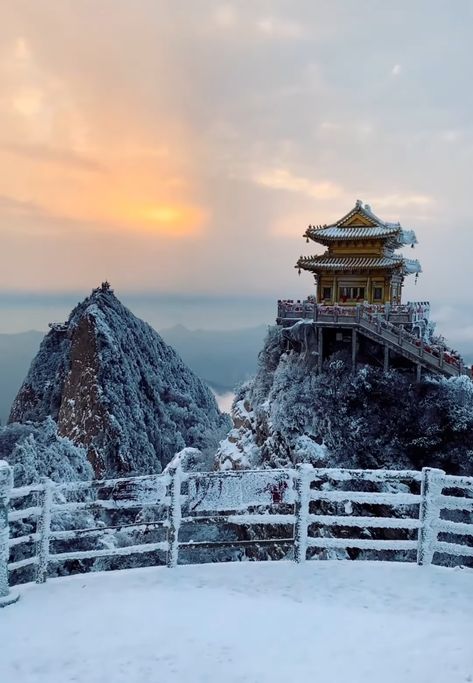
[0,0,473,343]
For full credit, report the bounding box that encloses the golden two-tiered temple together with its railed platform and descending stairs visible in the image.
[276,200,471,380]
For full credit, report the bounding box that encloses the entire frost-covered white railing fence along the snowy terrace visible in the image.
[0,462,473,605]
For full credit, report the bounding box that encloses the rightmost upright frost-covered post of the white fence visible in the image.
[417,467,445,565]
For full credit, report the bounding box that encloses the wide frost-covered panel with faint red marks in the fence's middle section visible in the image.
[188,470,295,512]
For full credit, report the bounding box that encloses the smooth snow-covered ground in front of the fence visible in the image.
[0,562,473,683]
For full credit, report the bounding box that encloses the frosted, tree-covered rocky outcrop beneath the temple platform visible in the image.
[216,323,473,475]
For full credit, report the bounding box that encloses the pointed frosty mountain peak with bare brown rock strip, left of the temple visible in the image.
[9,283,229,477]
